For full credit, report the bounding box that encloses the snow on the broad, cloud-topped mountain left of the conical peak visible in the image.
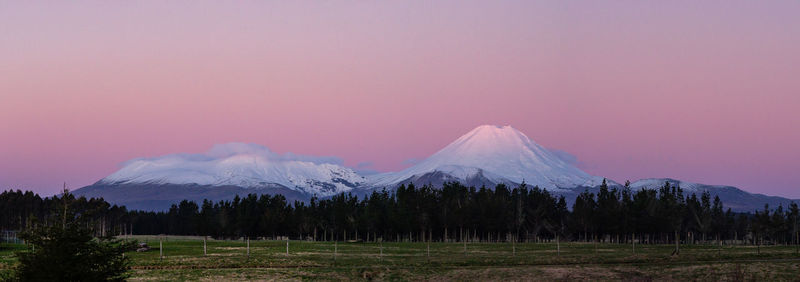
[98,143,366,196]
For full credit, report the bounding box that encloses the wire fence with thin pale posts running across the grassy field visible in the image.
[112,236,800,267]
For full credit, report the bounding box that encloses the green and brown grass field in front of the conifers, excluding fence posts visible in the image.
[0,236,800,281]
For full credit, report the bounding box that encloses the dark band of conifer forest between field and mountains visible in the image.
[0,181,800,244]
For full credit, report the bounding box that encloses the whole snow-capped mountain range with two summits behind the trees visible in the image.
[74,125,791,211]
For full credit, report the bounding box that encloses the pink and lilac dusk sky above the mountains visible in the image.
[0,1,800,198]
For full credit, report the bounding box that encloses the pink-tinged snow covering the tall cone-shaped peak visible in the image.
[368,125,603,190]
